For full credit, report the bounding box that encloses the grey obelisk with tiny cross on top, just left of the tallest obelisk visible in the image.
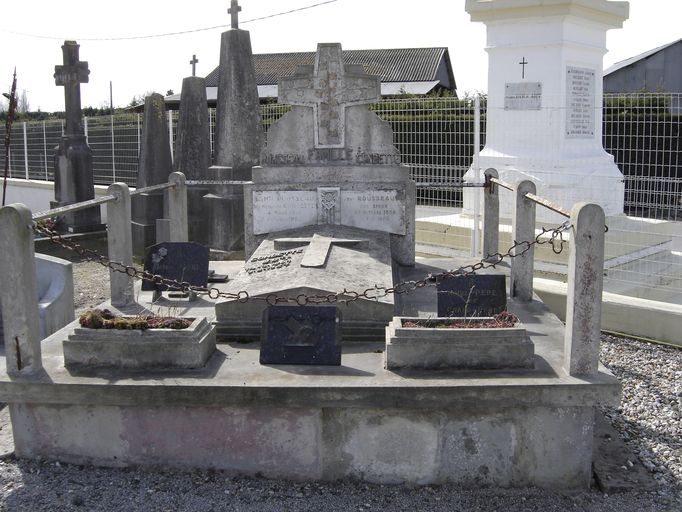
[173,56,211,245]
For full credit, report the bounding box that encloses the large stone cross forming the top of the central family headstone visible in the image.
[279,43,381,148]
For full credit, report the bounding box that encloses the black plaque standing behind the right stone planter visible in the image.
[436,274,507,317]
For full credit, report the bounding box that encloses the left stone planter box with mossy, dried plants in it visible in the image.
[63,317,215,369]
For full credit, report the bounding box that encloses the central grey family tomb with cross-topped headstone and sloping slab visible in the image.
[216,44,415,340]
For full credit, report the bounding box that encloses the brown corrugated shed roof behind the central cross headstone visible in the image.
[206,48,454,89]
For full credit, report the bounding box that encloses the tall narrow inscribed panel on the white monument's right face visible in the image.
[566,66,595,139]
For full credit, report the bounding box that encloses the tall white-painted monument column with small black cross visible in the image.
[464,0,629,222]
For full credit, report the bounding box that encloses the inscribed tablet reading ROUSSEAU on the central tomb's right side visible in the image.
[341,190,406,235]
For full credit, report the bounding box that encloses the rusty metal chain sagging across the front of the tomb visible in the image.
[33,221,571,306]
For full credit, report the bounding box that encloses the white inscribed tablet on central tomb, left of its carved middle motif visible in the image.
[253,190,317,235]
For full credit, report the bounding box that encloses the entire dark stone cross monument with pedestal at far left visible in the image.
[50,41,103,233]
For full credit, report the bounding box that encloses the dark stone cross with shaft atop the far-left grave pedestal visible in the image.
[54,41,90,135]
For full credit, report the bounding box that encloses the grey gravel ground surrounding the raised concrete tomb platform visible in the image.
[0,262,682,512]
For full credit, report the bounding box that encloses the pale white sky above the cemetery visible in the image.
[0,0,682,112]
